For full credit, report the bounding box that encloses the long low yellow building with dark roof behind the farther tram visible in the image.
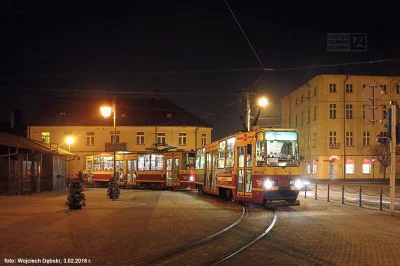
[27,98,212,169]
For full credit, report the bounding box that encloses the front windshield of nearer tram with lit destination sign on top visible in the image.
[265,131,299,166]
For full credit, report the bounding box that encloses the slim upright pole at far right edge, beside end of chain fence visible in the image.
[390,101,397,215]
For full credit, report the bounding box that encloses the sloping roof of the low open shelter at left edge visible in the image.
[0,132,75,156]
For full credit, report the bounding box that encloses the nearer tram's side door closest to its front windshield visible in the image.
[236,146,253,196]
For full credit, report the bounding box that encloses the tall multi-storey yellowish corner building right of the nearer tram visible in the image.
[281,75,400,180]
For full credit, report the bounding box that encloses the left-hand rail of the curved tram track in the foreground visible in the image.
[133,205,247,266]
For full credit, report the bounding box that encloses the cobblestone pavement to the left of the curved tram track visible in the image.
[0,189,242,265]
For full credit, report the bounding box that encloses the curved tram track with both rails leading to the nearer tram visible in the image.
[133,204,278,266]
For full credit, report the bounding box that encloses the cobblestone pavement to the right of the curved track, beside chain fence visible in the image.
[227,195,400,266]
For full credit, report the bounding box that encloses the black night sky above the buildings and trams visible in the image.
[0,0,400,140]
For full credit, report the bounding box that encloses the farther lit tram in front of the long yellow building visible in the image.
[83,151,195,189]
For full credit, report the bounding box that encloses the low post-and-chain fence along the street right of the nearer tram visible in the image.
[300,183,392,211]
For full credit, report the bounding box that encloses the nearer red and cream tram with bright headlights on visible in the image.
[194,127,302,206]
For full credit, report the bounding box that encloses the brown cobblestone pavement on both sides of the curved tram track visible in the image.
[0,189,400,265]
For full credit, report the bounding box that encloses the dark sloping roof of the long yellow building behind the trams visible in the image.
[30,97,211,128]
